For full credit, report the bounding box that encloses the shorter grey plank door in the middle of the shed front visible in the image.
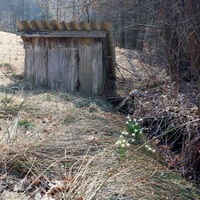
[48,48,78,93]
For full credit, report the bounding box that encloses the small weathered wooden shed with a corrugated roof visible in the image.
[17,20,115,95]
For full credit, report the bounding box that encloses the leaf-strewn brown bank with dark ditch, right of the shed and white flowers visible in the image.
[116,49,200,185]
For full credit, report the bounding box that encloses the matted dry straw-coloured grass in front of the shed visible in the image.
[0,91,198,200]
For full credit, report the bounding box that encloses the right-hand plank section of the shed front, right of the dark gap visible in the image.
[79,38,103,95]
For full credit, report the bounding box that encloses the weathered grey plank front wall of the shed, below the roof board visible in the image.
[25,38,106,95]
